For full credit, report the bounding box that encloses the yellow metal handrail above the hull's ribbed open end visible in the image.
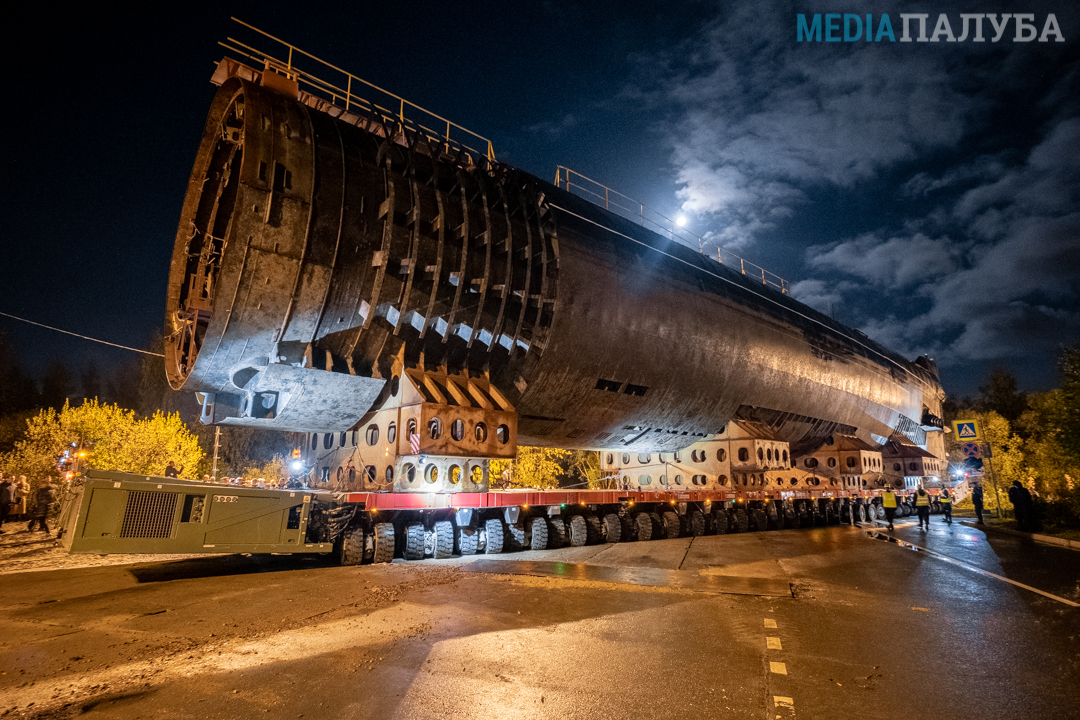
[219,17,495,162]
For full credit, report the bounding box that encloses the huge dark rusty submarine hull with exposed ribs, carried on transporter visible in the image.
[165,78,943,451]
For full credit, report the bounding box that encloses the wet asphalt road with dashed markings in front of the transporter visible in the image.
[0,517,1080,720]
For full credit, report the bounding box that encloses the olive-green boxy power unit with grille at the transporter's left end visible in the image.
[59,470,345,554]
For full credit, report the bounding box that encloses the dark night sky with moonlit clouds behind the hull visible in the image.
[0,0,1080,395]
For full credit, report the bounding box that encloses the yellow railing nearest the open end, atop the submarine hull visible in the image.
[218,17,495,162]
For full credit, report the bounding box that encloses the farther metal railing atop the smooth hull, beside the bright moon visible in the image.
[555,165,791,295]
